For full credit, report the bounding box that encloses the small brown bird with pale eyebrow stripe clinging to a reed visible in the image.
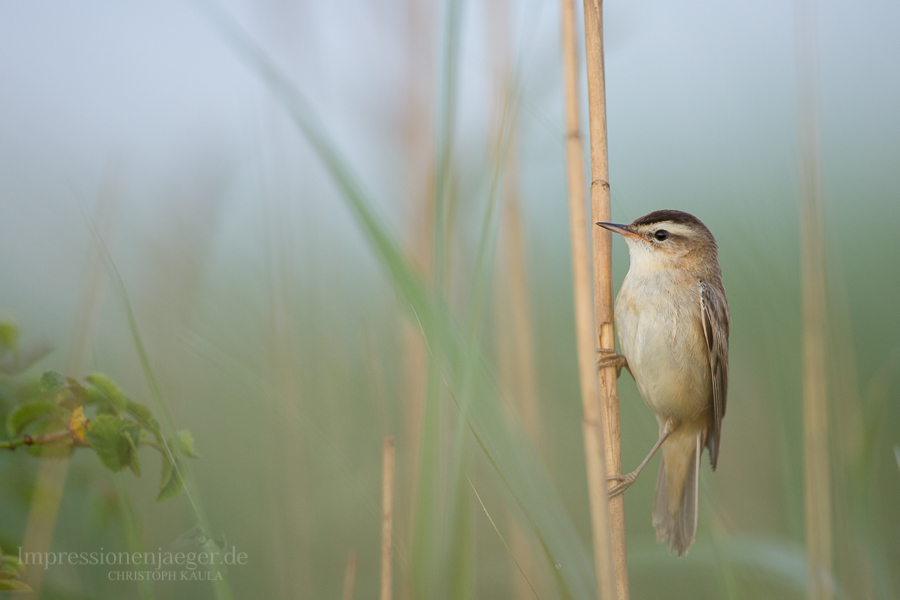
[597,210,731,556]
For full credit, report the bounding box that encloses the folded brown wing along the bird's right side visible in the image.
[700,281,731,470]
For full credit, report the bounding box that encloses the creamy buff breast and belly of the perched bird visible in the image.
[615,272,712,420]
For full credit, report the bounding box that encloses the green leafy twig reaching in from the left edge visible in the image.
[0,323,197,500]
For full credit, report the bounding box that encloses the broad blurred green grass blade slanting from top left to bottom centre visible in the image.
[196,0,594,599]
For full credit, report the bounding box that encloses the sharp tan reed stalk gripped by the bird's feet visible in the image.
[584,0,628,600]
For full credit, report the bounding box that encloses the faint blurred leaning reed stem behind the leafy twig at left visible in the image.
[22,168,123,598]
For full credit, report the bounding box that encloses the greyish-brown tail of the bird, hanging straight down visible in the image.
[653,427,702,556]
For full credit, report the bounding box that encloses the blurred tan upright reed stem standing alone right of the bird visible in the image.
[795,0,832,600]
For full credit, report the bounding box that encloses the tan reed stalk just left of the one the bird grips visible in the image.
[562,0,616,600]
